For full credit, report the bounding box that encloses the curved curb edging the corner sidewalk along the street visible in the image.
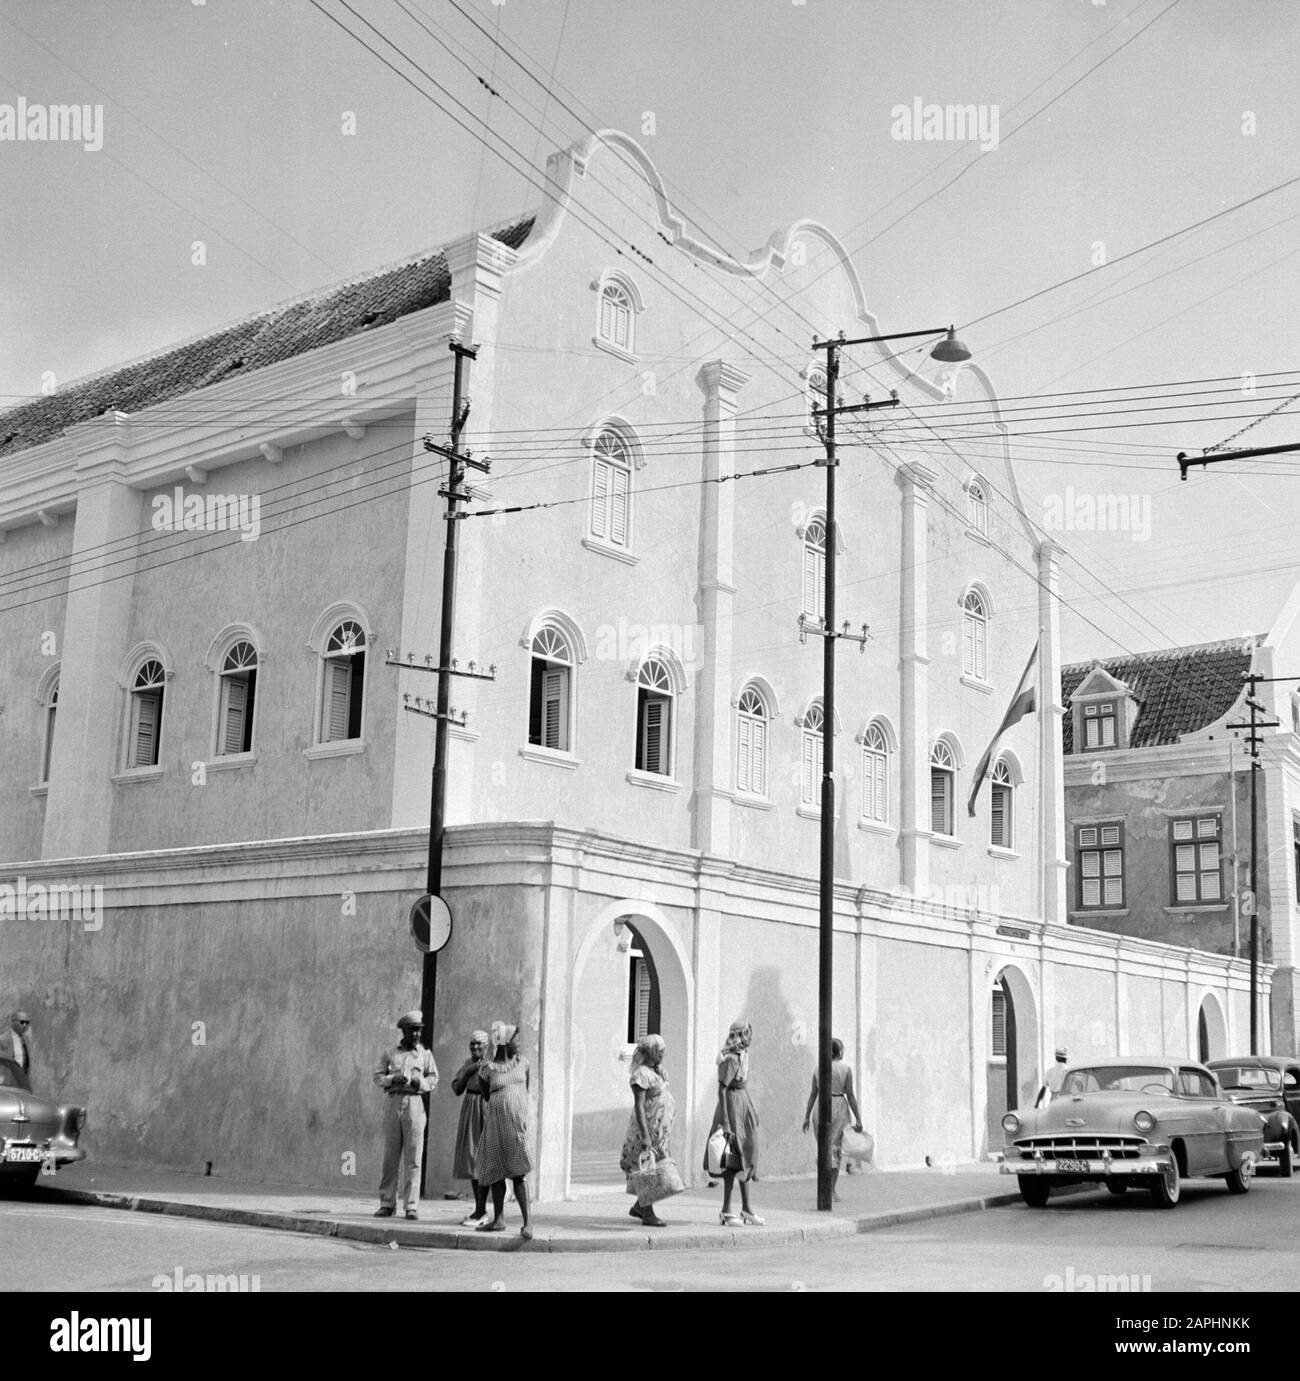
[41,1186,1038,1253]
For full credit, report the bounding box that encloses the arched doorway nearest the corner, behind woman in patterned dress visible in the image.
[568,905,691,1196]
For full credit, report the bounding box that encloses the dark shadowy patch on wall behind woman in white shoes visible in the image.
[699,967,816,1178]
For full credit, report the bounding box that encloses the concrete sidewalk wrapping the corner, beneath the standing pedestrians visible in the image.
[33,1161,1044,1251]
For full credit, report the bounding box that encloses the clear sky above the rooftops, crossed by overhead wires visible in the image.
[0,0,1300,670]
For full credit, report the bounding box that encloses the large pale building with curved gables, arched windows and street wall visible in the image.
[0,133,1268,1196]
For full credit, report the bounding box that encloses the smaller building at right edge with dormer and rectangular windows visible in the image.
[1061,591,1300,1055]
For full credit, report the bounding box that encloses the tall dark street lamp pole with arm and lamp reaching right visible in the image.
[812,326,970,1213]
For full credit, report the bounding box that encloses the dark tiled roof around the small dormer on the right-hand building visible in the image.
[1061,638,1261,753]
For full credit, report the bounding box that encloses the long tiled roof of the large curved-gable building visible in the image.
[0,217,533,457]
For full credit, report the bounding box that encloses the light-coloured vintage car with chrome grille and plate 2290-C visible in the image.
[1002,1055,1264,1208]
